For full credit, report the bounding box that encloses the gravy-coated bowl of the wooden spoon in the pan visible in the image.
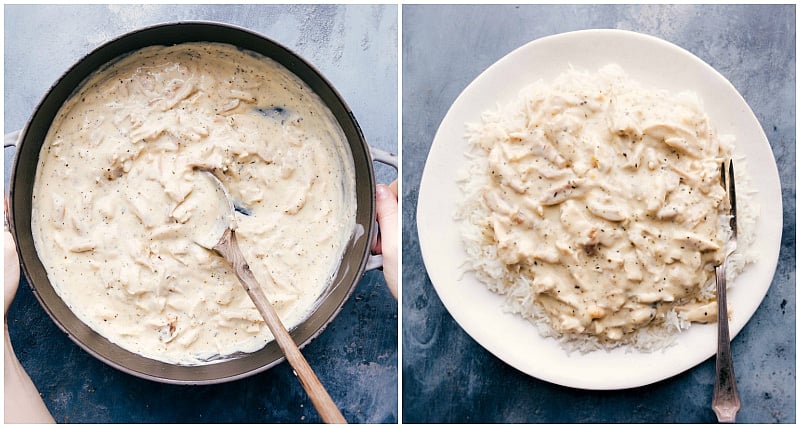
[191,168,236,249]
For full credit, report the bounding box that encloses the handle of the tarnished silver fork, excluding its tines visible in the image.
[711,263,741,423]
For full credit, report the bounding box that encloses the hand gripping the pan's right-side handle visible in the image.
[373,180,398,299]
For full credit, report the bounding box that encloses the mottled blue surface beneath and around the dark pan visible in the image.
[4,5,398,423]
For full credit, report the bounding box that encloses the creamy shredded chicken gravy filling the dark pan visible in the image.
[32,43,356,365]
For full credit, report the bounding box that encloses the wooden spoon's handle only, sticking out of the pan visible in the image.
[214,231,347,424]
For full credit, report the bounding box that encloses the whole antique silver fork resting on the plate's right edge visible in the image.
[711,160,741,422]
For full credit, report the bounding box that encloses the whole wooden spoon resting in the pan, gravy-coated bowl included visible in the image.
[193,168,347,424]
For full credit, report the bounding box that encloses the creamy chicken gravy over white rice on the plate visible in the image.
[457,65,752,350]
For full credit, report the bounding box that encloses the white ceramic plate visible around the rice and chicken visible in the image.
[417,30,782,389]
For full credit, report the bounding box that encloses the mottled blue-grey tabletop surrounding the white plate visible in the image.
[402,5,796,423]
